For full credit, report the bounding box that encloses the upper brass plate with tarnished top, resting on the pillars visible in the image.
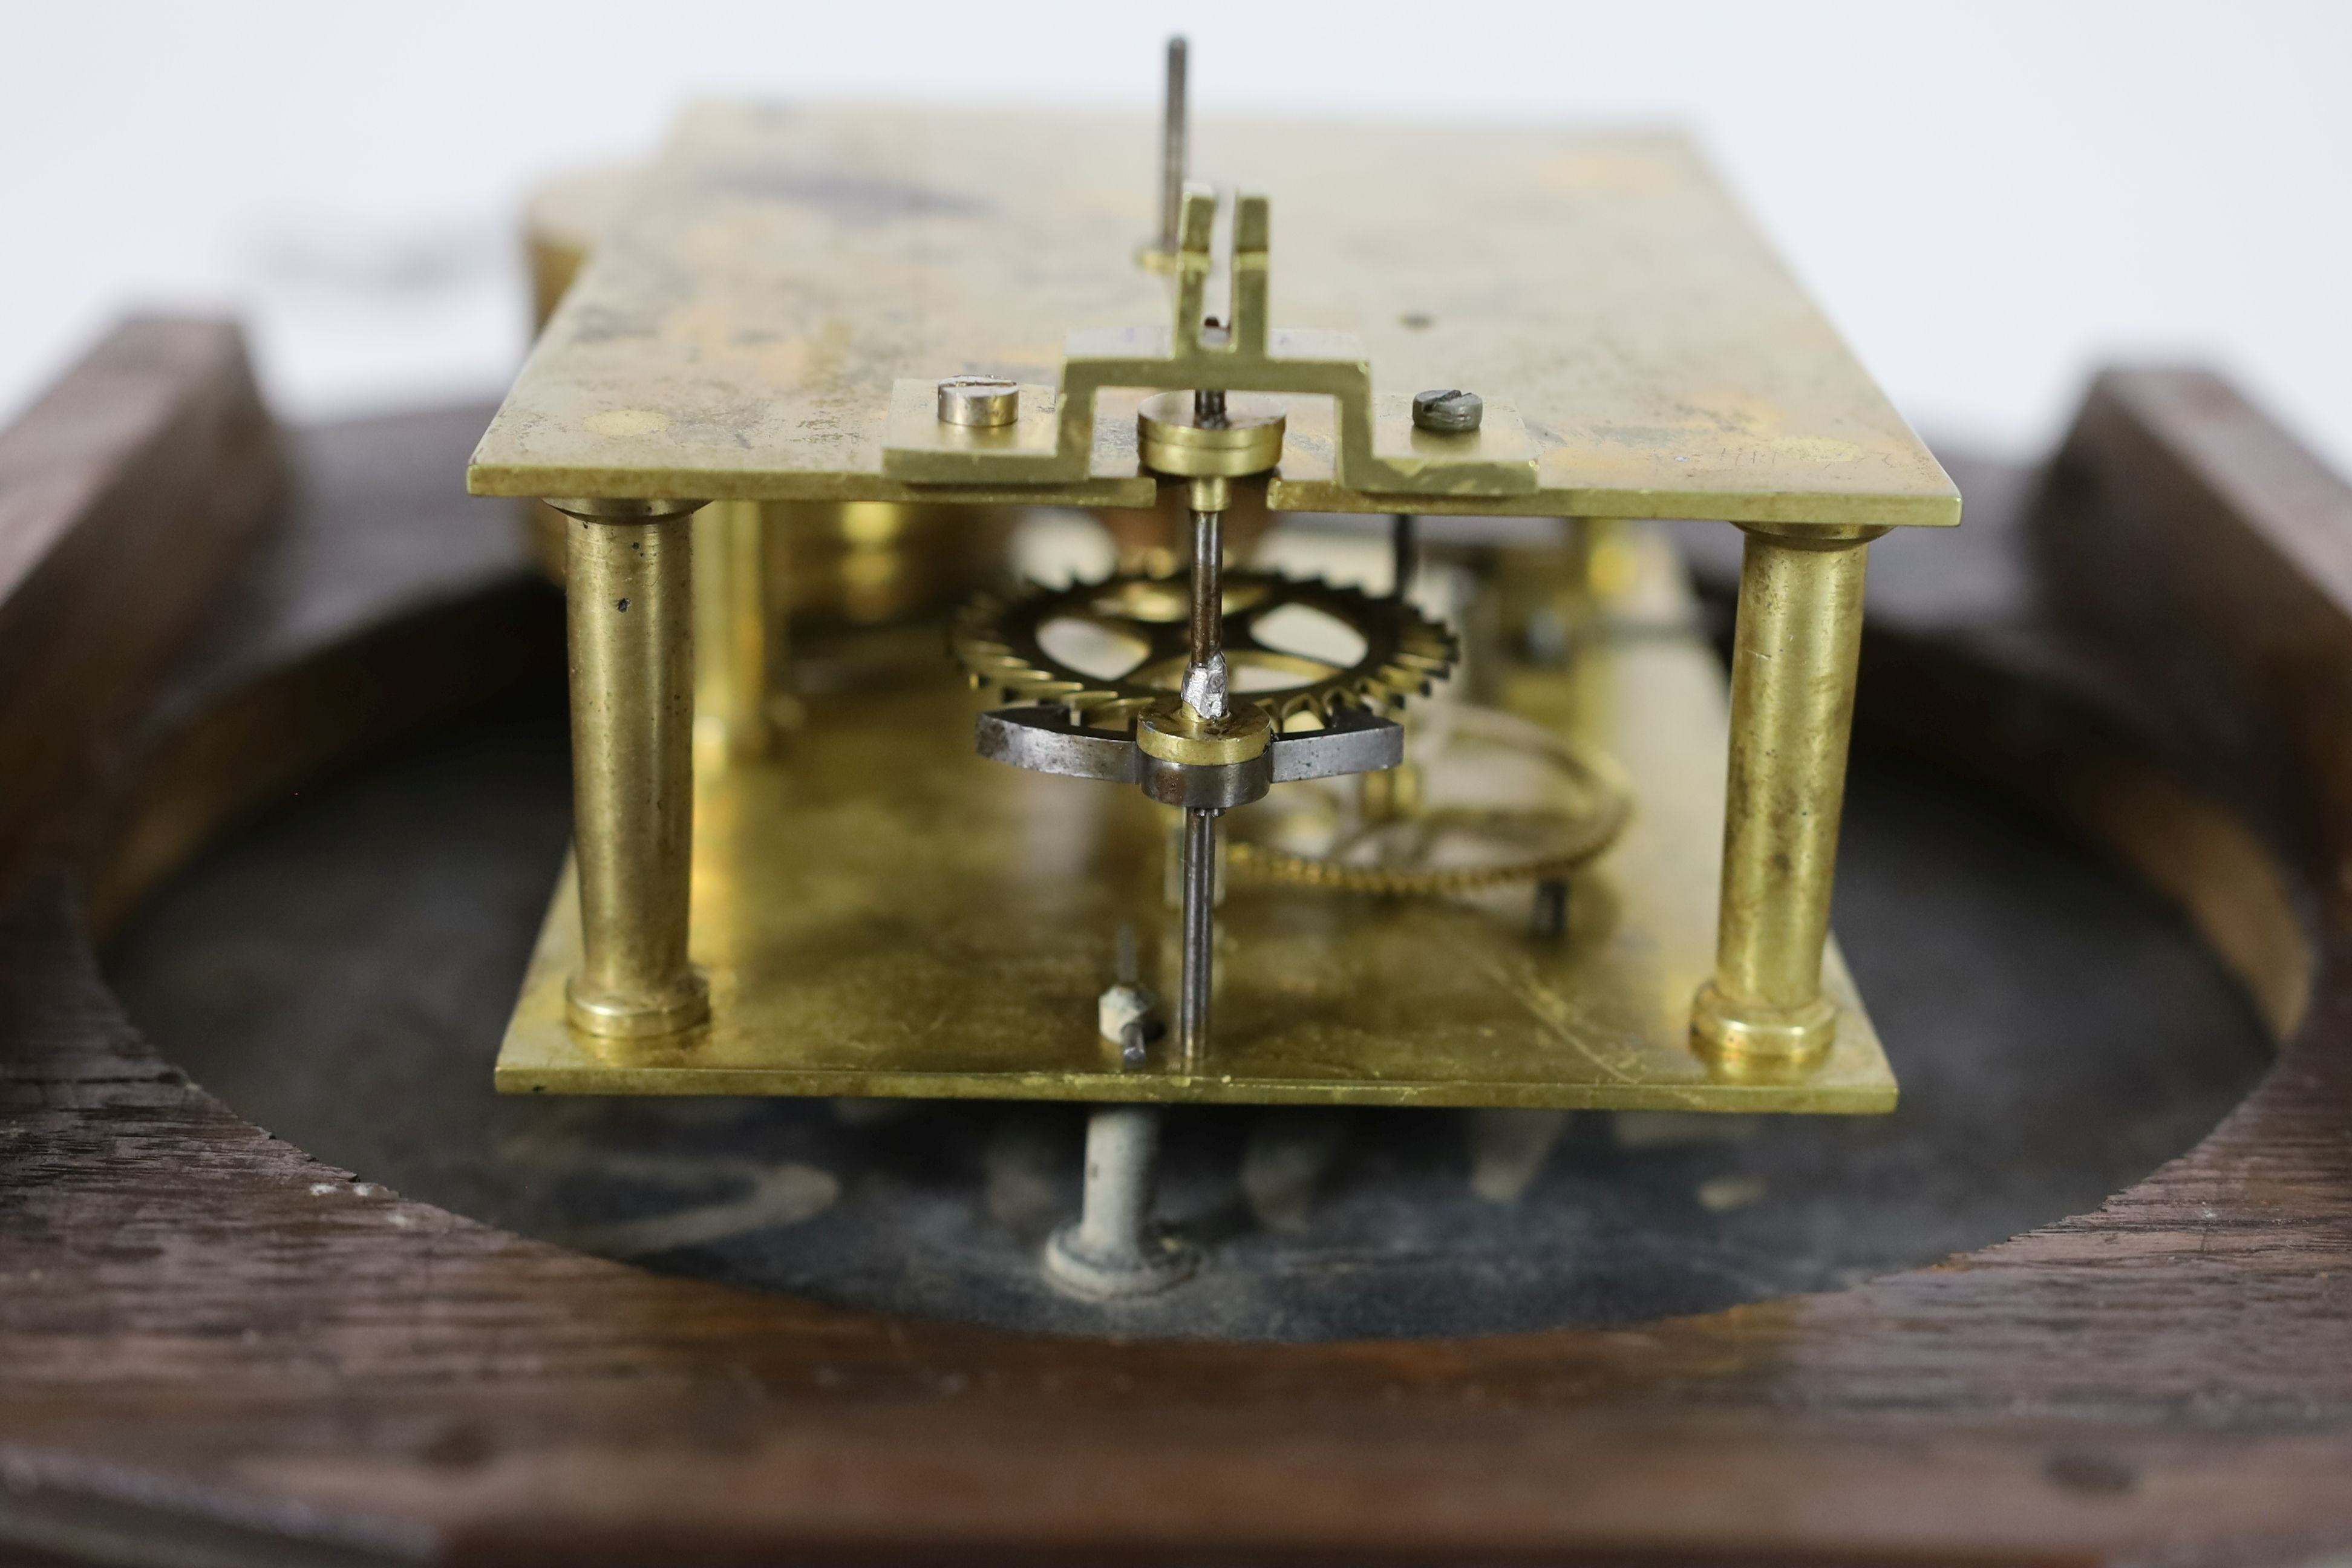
[468,106,1959,524]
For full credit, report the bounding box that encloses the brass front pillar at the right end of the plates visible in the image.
[1691,524,1884,1074]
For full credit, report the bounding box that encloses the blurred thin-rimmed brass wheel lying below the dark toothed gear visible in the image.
[1228,708,1632,898]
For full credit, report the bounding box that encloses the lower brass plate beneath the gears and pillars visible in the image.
[498,541,1896,1112]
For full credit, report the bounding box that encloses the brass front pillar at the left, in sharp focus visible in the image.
[548,501,710,1037]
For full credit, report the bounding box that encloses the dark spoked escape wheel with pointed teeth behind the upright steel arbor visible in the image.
[948,571,1456,729]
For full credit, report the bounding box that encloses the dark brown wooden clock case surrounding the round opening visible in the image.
[0,324,2352,1563]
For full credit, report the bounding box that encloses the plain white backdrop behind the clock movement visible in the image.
[0,0,2352,470]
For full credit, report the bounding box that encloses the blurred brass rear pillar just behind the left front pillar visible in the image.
[694,501,783,762]
